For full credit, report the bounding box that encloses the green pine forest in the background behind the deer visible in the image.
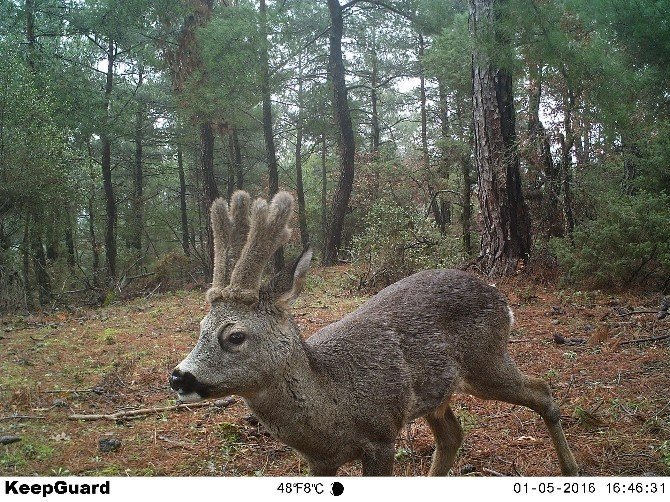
[0,0,670,311]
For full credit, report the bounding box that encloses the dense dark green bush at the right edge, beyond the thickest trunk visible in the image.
[551,190,670,291]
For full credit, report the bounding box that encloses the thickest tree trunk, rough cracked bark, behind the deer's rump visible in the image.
[470,0,530,276]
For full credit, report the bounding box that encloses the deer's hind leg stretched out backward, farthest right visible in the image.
[468,356,579,476]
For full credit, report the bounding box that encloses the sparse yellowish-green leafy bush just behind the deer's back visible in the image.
[352,197,464,289]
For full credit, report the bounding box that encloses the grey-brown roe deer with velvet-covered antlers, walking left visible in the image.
[170,191,577,476]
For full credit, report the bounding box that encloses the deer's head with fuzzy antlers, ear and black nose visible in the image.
[170,191,312,402]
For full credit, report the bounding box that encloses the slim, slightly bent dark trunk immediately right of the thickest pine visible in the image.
[528,65,563,237]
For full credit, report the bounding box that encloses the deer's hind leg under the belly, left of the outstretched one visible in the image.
[424,403,463,476]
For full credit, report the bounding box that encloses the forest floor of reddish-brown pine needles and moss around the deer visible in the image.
[0,267,670,476]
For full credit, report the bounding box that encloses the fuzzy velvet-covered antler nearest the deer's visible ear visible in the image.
[230,192,293,298]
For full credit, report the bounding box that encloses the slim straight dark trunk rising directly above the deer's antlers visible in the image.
[260,0,284,272]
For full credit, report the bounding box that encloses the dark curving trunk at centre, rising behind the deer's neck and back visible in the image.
[324,0,356,265]
